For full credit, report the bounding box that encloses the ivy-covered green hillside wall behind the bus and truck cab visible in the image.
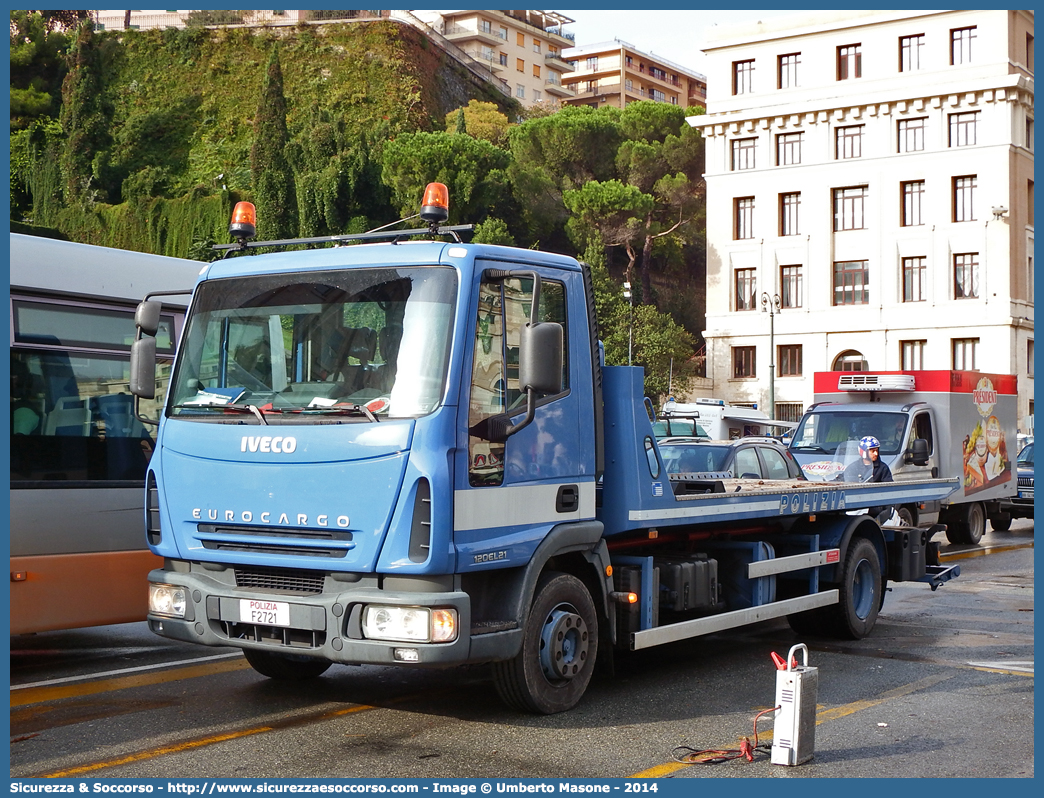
[11,22,517,257]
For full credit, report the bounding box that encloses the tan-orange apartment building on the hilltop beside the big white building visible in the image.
[563,39,707,108]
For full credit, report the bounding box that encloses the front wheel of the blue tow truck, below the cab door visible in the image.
[493,571,598,714]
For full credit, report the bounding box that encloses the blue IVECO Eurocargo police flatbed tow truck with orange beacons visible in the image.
[132,189,959,713]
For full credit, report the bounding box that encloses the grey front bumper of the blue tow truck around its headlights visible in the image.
[148,561,521,667]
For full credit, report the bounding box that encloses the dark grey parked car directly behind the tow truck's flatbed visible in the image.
[657,438,805,479]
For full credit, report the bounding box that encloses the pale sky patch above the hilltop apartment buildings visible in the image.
[554,8,793,75]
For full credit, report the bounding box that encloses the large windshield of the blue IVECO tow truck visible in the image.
[168,266,457,423]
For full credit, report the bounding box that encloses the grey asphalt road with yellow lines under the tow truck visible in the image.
[10,521,1034,779]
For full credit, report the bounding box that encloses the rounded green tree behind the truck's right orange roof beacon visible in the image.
[381,132,508,225]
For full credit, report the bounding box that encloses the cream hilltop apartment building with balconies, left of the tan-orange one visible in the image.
[412,10,575,108]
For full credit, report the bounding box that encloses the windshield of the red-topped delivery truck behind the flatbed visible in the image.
[790,409,907,456]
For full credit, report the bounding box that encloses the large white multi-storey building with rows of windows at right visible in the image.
[689,10,1034,431]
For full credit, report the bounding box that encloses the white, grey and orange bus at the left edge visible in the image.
[9,233,204,634]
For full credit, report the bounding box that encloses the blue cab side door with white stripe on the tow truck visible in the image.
[454,264,594,571]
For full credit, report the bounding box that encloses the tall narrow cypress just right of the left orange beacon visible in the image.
[251,47,298,240]
